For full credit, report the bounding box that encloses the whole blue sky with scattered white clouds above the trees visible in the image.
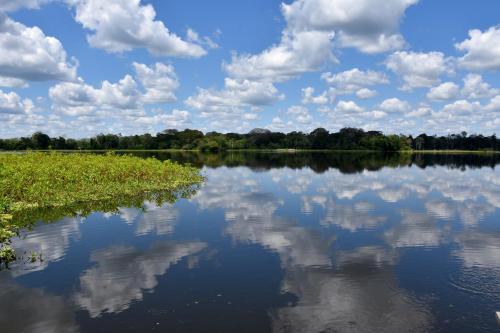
[0,0,500,138]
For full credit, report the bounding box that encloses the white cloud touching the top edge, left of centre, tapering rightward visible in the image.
[69,0,206,57]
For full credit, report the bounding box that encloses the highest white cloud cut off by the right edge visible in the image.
[455,27,500,70]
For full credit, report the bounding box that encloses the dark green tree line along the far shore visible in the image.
[0,128,500,152]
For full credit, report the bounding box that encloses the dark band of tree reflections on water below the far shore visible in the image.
[136,151,500,174]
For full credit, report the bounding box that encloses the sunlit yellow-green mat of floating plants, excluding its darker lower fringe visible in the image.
[0,153,202,211]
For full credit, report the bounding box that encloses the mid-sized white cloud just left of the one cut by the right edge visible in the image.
[385,51,452,90]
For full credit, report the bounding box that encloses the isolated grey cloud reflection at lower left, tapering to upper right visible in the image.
[74,242,206,317]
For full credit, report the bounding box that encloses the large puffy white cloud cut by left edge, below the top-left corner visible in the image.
[0,13,76,86]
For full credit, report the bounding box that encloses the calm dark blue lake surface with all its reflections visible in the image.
[0,153,500,332]
